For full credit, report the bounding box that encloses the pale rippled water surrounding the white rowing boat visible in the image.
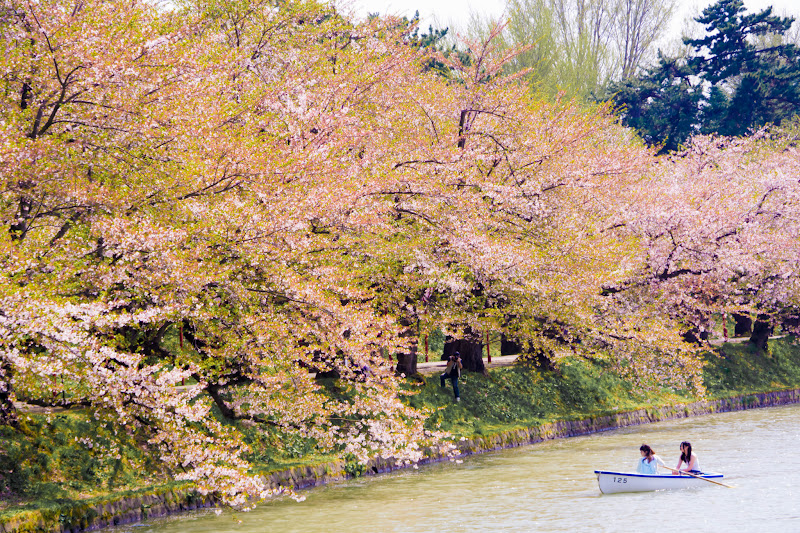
[109,405,800,533]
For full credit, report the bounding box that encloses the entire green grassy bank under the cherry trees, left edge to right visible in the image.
[0,337,800,523]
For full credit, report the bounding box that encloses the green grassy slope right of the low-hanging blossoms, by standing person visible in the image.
[410,337,800,437]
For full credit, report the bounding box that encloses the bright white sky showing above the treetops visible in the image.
[345,0,800,47]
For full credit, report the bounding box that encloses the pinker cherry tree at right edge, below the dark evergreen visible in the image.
[604,123,800,360]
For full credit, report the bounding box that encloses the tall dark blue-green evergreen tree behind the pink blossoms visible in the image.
[605,0,800,152]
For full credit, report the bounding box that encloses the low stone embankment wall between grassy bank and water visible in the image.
[0,389,800,533]
